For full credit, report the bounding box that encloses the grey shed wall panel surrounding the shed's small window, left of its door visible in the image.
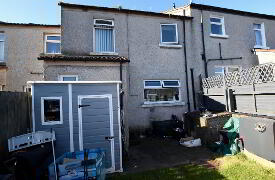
[34,84,70,156]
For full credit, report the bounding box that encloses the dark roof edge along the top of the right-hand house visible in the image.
[189,3,275,20]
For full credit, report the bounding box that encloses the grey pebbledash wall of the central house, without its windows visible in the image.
[44,5,193,128]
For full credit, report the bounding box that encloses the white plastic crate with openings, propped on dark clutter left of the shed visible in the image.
[8,131,55,152]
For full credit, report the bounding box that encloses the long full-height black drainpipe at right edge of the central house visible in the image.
[183,10,191,112]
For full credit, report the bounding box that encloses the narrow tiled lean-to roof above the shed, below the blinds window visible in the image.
[37,55,130,63]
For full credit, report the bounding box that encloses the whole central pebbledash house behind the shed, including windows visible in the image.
[38,2,192,141]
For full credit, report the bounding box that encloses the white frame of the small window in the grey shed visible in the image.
[41,96,63,125]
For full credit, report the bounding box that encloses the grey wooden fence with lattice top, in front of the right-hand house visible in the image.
[203,64,275,116]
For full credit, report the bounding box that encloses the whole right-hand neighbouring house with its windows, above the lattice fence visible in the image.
[164,3,275,105]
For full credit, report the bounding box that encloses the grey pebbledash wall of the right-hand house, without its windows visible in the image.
[165,4,275,109]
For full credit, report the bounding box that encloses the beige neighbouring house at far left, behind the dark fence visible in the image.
[0,22,60,92]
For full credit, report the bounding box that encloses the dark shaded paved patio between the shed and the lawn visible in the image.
[124,138,217,173]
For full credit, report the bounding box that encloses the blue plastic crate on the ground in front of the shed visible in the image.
[48,149,106,180]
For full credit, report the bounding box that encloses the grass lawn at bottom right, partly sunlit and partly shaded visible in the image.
[108,153,275,180]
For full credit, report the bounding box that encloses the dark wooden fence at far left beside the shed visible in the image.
[0,91,32,161]
